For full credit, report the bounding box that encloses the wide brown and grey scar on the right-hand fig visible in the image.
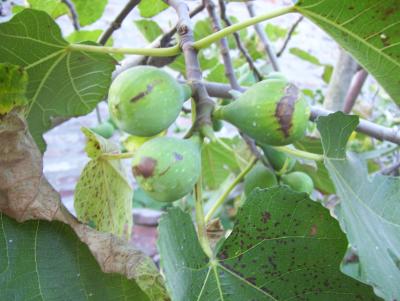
[275,84,299,138]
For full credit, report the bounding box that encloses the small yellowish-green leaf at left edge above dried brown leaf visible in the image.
[0,63,28,115]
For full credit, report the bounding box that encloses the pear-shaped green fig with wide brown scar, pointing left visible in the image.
[213,79,310,146]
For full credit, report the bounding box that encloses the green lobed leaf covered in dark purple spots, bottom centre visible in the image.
[158,187,379,301]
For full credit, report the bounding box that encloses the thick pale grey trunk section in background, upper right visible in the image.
[324,49,358,111]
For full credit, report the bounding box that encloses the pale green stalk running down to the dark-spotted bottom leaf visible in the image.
[194,176,213,258]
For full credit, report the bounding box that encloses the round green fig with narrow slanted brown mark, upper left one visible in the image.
[108,66,191,137]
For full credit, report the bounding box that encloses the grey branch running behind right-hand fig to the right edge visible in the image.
[205,82,400,144]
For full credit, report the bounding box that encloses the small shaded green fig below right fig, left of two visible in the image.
[244,163,278,196]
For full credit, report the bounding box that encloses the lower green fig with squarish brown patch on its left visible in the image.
[132,137,201,202]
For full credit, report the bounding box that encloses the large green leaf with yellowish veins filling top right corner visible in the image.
[295,0,400,104]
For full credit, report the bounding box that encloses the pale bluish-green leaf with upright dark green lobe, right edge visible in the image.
[317,112,400,300]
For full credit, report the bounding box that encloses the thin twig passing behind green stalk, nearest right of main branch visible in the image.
[206,0,240,91]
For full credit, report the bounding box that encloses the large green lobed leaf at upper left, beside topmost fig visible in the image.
[0,9,115,151]
